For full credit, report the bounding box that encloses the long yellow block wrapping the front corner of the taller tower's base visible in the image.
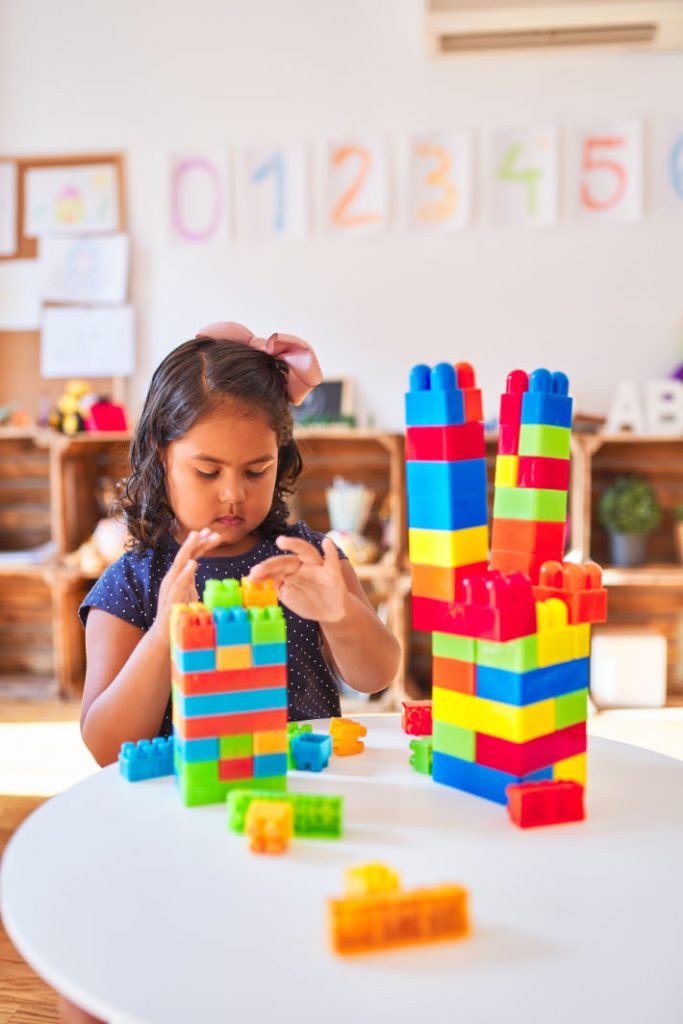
[432,686,555,743]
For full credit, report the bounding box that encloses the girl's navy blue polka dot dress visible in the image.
[79,520,345,736]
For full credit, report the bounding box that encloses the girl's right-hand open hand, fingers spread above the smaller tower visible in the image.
[249,537,351,624]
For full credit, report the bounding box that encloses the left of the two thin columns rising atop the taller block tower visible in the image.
[405,362,488,631]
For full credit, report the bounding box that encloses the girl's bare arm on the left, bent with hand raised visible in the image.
[81,529,220,765]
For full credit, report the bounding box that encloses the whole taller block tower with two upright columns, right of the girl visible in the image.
[405,364,606,804]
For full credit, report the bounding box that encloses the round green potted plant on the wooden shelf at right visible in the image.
[598,476,661,566]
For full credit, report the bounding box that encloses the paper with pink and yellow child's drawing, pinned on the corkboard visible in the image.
[24,164,119,239]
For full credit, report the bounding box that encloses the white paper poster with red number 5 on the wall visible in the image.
[572,121,643,223]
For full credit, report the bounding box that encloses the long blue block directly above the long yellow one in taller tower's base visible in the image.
[476,657,591,707]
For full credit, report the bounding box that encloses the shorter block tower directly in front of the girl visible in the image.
[171,579,288,807]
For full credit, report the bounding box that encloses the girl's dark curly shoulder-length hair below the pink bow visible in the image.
[115,338,302,554]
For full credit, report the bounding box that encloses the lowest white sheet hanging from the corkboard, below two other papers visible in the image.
[40,306,135,378]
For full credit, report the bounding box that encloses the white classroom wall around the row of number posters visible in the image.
[0,0,683,429]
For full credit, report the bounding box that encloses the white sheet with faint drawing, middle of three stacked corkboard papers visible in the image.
[38,234,129,305]
